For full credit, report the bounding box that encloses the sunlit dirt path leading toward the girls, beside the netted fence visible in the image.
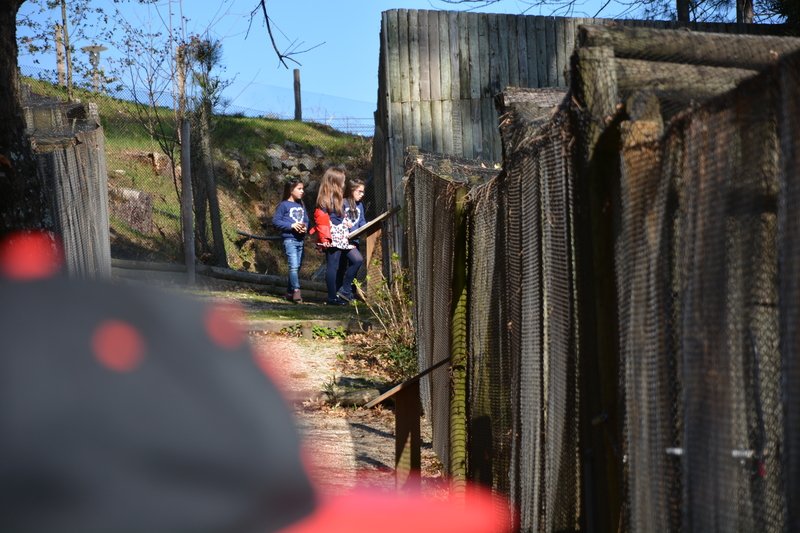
[251,333,446,497]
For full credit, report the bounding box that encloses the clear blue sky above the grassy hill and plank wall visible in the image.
[14,0,636,119]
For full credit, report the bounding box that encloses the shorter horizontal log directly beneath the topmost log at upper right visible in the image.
[614,58,758,99]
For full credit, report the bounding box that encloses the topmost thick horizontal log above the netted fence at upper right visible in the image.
[579,26,800,70]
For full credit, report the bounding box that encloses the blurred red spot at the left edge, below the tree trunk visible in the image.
[0,230,64,281]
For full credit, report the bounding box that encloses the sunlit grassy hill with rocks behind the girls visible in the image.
[23,78,371,277]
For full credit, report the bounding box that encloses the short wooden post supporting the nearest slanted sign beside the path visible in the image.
[394,380,422,492]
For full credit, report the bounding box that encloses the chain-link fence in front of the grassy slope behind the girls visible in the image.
[21,67,381,286]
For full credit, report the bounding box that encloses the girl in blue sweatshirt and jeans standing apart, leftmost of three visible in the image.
[272,178,308,303]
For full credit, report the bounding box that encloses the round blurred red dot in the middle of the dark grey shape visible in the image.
[92,320,145,372]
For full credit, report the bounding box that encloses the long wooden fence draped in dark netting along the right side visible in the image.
[407,23,800,532]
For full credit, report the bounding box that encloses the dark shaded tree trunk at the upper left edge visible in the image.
[0,0,53,235]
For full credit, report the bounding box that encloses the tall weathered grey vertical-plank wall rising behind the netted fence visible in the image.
[373,9,775,250]
